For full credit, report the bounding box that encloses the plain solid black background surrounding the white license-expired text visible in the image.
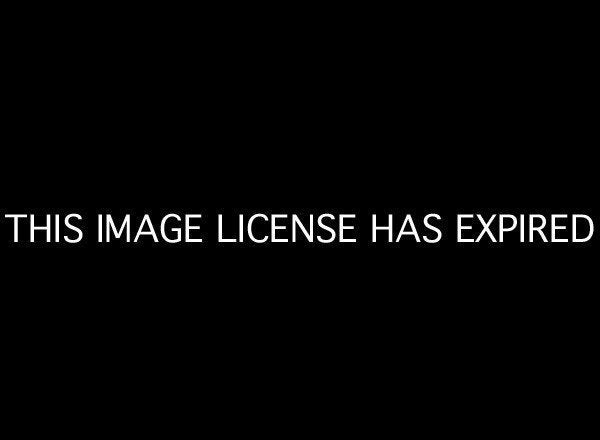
[1,5,598,433]
